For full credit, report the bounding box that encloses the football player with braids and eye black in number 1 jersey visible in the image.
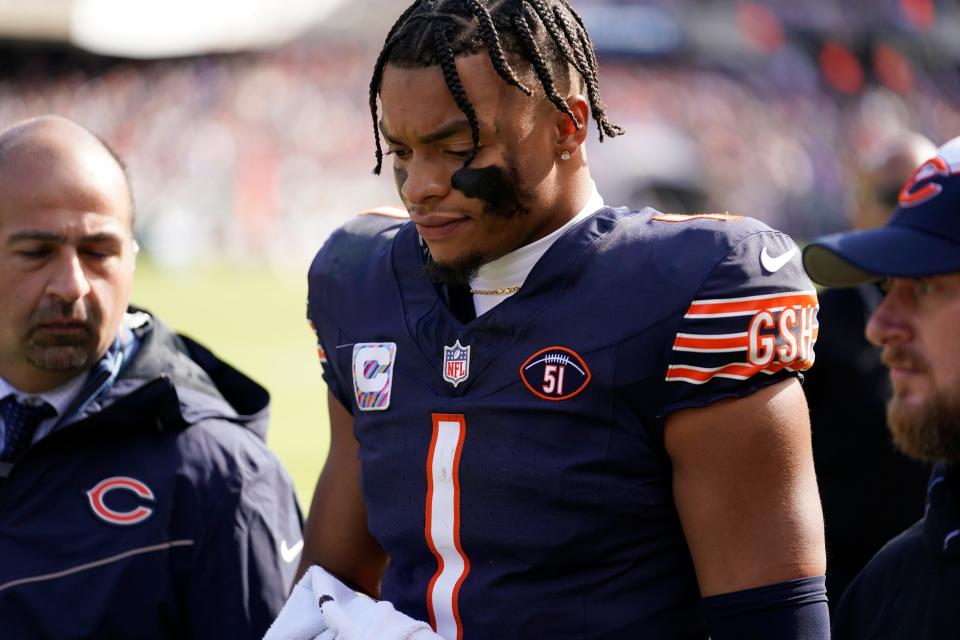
[305,0,828,640]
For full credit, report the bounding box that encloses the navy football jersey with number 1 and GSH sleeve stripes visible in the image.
[308,208,817,640]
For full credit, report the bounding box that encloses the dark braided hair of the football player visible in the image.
[370,0,623,174]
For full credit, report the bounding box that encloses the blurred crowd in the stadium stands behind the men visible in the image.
[0,0,960,271]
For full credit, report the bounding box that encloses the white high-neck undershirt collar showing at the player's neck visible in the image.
[470,181,605,316]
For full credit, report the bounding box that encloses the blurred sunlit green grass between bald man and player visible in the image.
[133,260,329,510]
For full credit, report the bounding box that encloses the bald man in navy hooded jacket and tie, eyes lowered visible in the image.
[0,112,301,639]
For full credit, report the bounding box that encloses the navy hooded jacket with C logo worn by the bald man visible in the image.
[0,313,302,640]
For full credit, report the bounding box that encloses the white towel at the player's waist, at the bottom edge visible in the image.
[264,566,443,640]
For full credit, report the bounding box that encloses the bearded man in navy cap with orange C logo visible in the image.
[803,138,960,640]
